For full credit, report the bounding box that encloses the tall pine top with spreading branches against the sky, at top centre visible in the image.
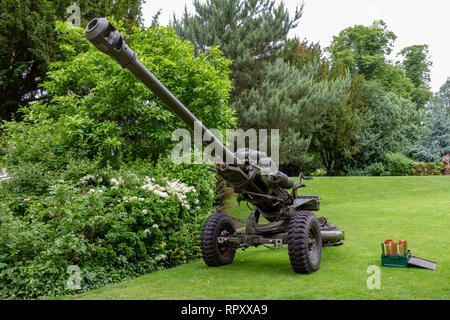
[171,0,303,98]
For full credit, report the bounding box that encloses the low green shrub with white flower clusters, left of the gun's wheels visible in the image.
[0,159,215,298]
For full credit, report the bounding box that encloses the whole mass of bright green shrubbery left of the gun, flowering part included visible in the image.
[0,19,234,298]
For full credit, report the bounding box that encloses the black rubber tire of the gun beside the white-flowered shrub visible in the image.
[200,212,236,267]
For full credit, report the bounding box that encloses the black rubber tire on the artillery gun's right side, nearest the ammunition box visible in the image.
[287,211,322,274]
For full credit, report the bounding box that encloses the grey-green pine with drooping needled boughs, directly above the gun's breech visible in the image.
[236,59,350,168]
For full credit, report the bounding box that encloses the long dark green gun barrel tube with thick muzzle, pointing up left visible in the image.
[86,18,237,163]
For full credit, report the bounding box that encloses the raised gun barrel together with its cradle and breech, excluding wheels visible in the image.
[86,18,294,221]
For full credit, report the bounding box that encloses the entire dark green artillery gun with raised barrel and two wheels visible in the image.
[86,18,344,273]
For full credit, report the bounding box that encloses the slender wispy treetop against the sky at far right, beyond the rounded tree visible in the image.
[399,44,433,108]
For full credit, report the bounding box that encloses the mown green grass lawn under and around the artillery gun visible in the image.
[59,176,450,300]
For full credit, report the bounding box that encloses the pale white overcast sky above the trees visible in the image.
[143,0,450,92]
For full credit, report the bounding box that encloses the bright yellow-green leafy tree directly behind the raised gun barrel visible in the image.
[4,23,234,165]
